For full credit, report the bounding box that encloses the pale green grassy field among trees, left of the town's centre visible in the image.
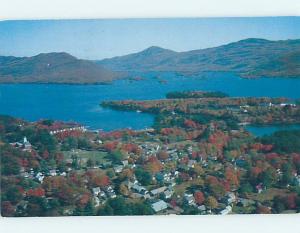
[63,149,107,163]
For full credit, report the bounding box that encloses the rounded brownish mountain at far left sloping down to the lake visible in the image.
[0,53,119,84]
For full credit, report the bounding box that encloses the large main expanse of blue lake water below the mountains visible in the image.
[0,72,300,131]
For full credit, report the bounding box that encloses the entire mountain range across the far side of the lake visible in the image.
[0,38,300,84]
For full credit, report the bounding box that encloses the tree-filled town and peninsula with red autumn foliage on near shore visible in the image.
[0,92,300,216]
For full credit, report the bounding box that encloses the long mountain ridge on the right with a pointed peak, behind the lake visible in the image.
[98,38,300,77]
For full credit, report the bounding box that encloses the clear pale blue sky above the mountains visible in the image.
[0,17,300,60]
